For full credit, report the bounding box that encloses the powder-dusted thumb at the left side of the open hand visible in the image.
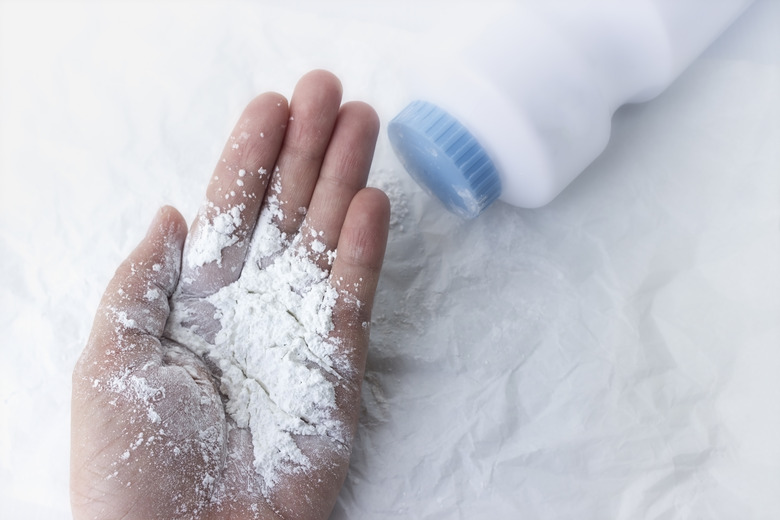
[77,206,187,371]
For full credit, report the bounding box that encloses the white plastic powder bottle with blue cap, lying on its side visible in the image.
[388,0,752,218]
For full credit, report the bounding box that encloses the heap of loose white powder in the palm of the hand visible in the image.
[166,194,345,487]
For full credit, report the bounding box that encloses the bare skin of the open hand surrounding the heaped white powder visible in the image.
[71,71,390,519]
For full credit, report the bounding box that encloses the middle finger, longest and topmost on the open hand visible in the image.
[272,70,342,236]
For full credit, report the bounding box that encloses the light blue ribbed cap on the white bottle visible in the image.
[387,101,501,218]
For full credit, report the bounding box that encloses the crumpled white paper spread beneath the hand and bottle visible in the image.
[0,0,780,519]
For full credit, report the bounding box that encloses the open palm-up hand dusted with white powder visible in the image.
[71,71,389,519]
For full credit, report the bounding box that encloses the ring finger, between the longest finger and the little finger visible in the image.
[301,102,379,269]
